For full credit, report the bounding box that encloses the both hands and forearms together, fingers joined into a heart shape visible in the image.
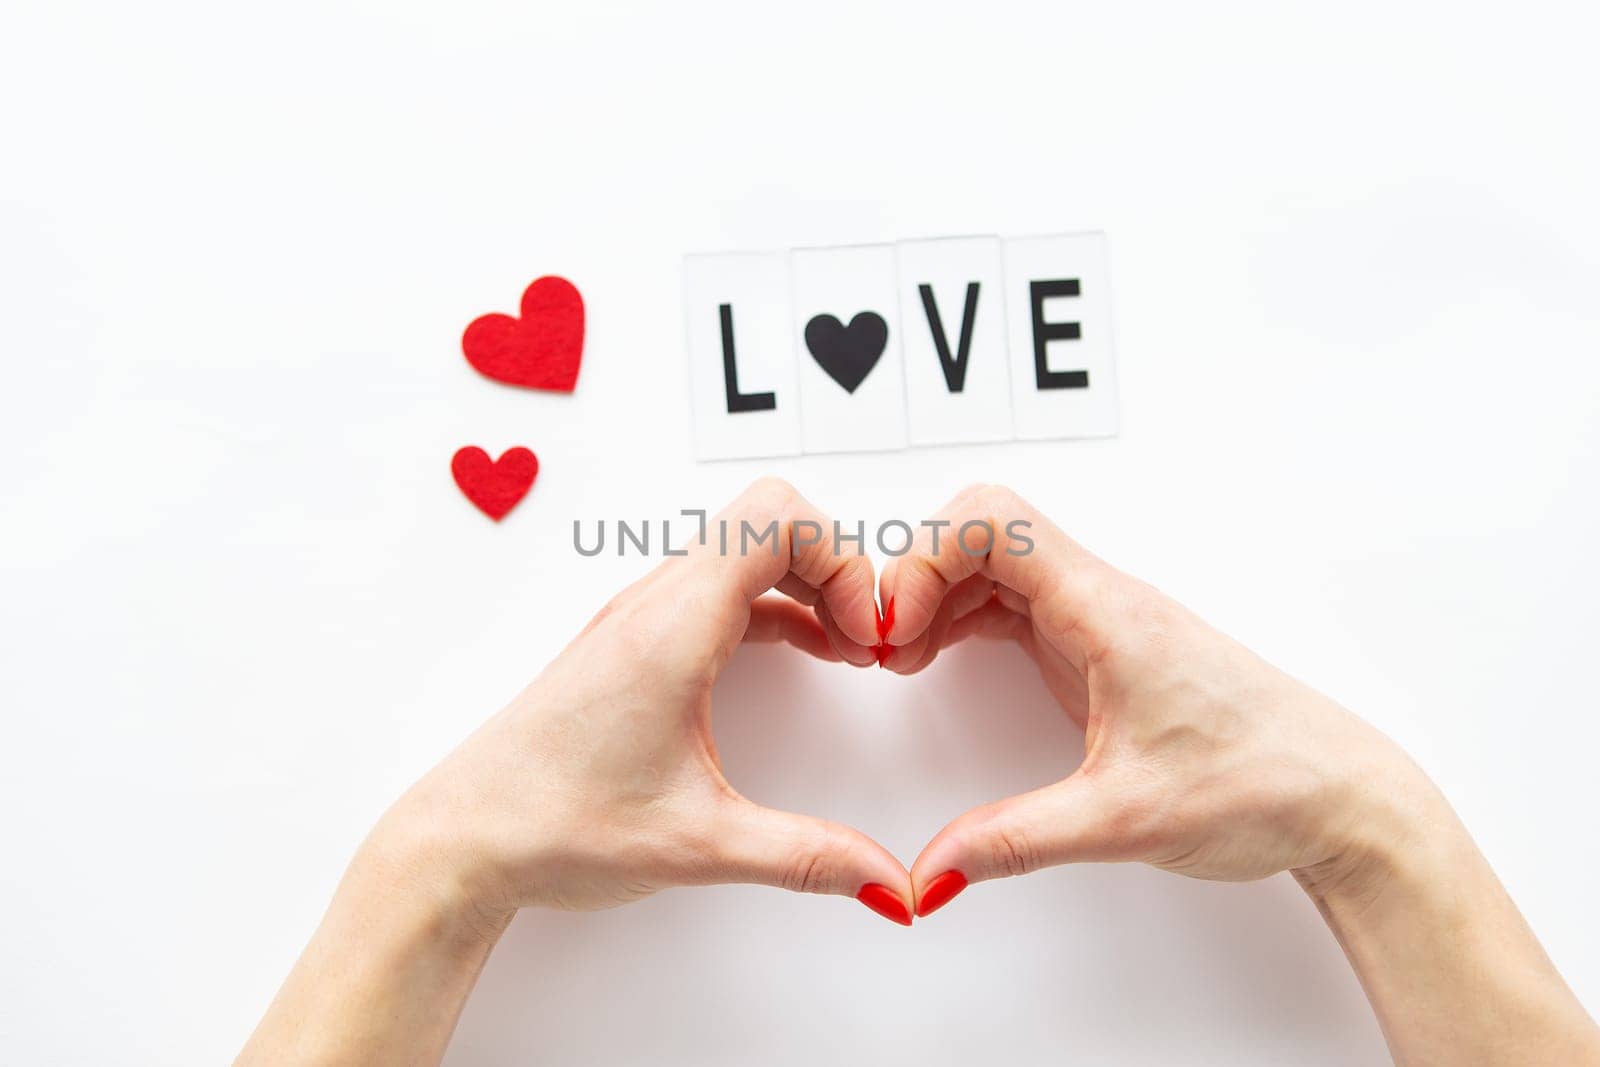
[240,470,1600,1064]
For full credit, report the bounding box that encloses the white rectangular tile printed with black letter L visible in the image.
[681,251,800,459]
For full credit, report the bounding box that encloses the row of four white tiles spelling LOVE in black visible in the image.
[685,234,1117,459]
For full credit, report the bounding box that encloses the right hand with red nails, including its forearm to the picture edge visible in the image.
[880,486,1600,1064]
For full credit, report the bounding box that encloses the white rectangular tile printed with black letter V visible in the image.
[894,237,1011,445]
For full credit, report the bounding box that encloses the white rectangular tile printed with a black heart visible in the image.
[789,245,906,453]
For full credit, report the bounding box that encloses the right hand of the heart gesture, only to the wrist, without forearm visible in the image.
[878,486,1451,915]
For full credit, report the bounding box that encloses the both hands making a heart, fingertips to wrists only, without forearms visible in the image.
[397,480,1426,923]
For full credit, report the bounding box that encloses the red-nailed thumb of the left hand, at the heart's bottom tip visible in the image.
[710,797,910,926]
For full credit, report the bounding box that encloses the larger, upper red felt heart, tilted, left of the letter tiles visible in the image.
[461,275,584,392]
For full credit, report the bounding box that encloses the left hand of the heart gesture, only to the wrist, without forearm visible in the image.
[378,480,910,923]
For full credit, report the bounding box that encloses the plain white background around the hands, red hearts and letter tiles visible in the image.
[0,2,1600,1065]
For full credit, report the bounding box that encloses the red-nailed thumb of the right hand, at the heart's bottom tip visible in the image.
[910,771,1123,917]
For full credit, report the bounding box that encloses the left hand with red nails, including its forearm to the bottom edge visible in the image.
[238,482,910,1064]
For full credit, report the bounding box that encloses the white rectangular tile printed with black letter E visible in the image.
[1005,234,1118,440]
